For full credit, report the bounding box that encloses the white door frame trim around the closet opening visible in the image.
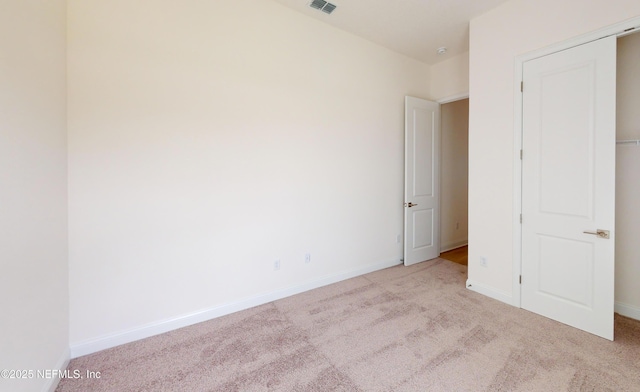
[511,17,640,308]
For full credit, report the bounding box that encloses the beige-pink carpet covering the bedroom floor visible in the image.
[57,259,640,392]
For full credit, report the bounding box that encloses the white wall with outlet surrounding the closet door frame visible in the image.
[469,0,640,300]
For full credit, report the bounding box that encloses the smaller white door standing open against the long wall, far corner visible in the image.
[404,97,440,265]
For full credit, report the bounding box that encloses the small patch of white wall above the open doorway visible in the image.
[429,52,469,101]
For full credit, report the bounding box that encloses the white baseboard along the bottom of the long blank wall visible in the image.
[71,259,402,358]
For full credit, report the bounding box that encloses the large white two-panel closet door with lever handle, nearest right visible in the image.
[521,37,616,340]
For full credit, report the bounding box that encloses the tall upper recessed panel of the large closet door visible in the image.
[535,62,595,217]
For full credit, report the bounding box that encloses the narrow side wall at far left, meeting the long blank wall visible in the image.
[0,0,69,391]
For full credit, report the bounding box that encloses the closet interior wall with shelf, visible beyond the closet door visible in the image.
[616,34,640,316]
